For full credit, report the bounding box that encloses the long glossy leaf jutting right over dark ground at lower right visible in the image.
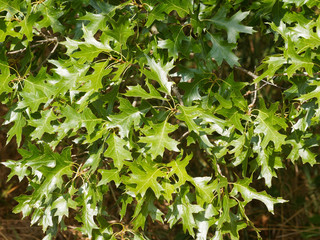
[232,178,286,213]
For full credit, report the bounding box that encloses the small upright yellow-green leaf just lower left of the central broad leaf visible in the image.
[104,132,132,170]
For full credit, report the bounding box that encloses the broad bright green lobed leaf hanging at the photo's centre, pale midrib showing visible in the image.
[139,121,180,158]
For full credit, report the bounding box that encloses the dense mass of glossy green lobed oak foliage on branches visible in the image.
[0,0,320,240]
